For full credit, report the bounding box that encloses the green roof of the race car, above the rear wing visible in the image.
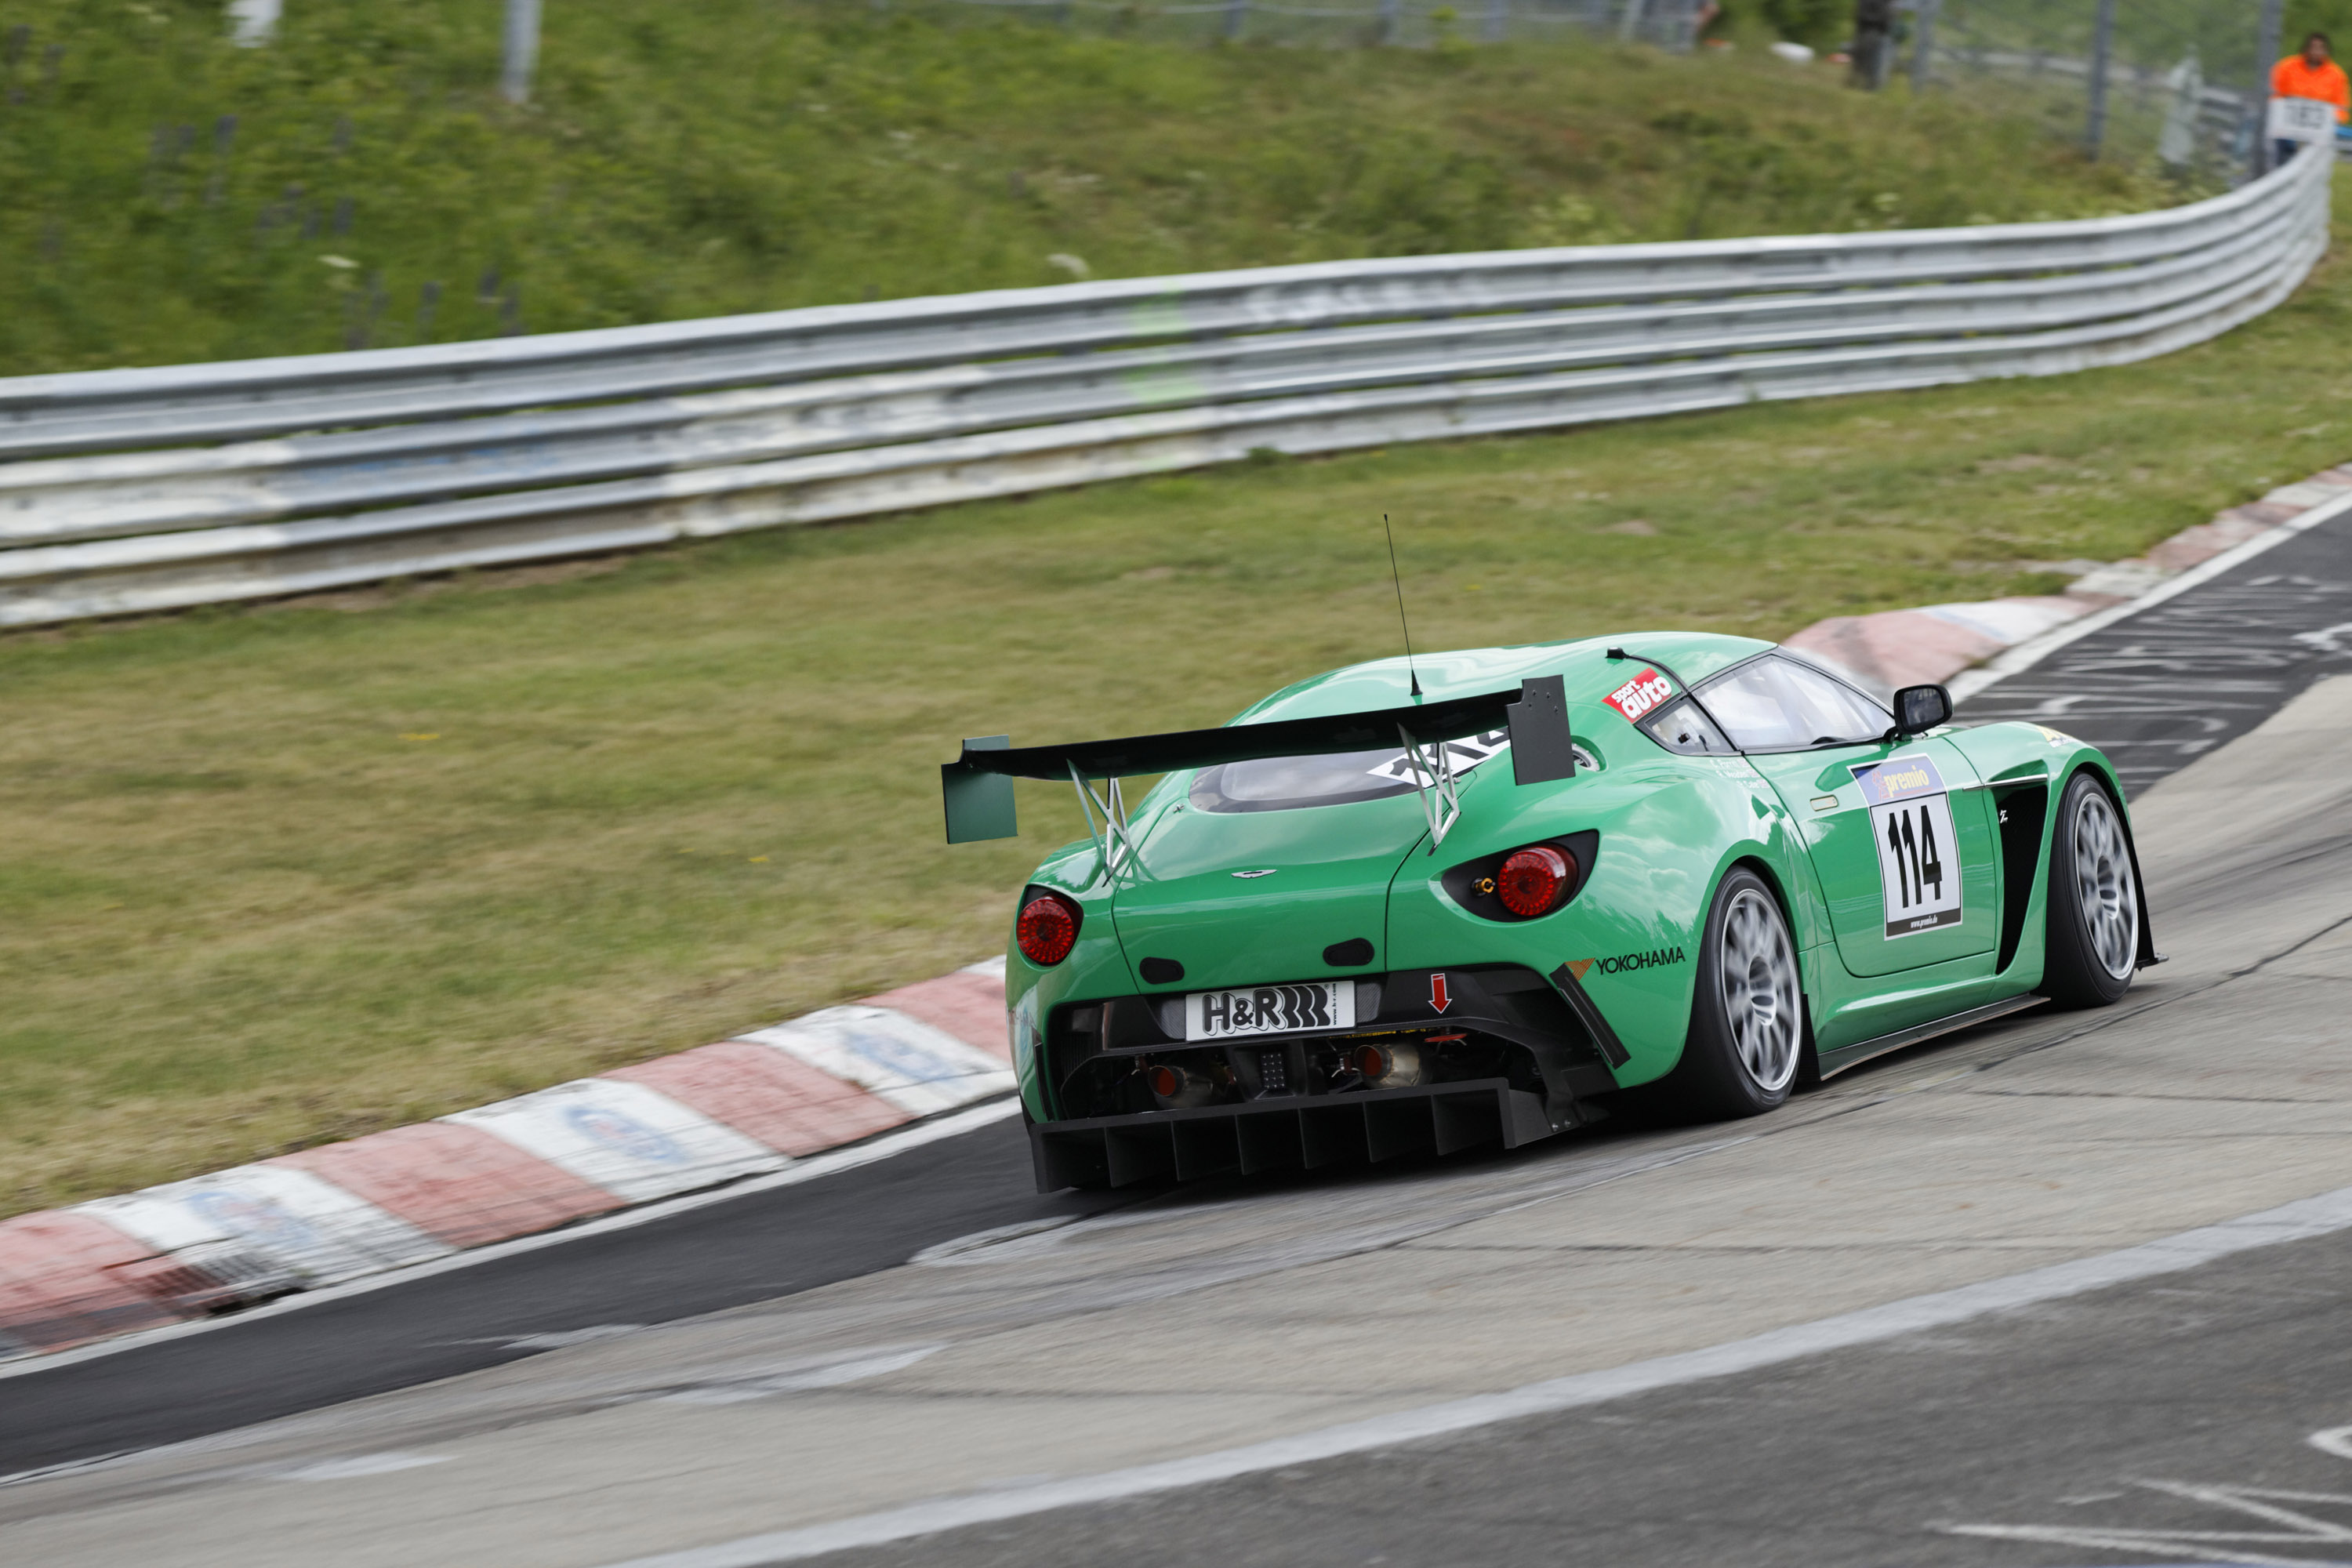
[1232,633,1773,724]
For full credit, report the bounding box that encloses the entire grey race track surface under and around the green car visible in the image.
[0,505,2352,1568]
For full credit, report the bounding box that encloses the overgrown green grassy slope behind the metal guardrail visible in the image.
[0,0,2180,374]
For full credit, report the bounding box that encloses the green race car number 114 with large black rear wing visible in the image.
[943,633,2159,1189]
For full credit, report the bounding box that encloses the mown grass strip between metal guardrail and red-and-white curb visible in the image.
[0,175,2352,1208]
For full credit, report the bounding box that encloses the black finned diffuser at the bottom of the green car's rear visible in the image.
[1030,1079,1555,1192]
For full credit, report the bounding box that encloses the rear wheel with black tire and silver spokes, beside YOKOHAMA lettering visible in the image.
[1661,867,1809,1121]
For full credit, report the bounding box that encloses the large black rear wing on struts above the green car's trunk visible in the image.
[938,675,1576,860]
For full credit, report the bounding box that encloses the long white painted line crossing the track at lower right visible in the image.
[593,1187,2352,1568]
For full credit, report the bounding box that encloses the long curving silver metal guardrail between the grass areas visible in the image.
[0,158,2333,626]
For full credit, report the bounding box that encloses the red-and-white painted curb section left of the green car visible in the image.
[0,959,1014,1356]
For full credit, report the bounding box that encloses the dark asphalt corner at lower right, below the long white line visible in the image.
[833,1213,2352,1568]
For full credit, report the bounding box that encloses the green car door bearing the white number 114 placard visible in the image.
[1750,739,1999,975]
